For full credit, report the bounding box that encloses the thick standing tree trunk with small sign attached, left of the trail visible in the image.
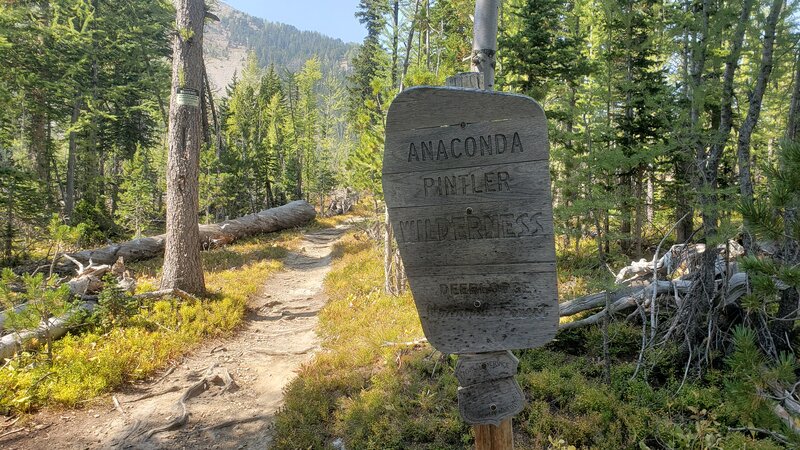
[161,0,205,294]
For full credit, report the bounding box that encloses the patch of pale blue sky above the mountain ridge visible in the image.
[222,0,367,42]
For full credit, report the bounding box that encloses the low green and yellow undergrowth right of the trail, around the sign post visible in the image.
[275,230,789,449]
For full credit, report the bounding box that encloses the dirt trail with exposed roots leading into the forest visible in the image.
[0,227,346,450]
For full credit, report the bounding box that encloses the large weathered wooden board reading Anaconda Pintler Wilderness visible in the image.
[383,87,558,353]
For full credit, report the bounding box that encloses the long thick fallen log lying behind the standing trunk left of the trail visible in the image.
[58,200,316,272]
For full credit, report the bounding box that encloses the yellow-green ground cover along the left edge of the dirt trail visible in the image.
[0,224,304,414]
